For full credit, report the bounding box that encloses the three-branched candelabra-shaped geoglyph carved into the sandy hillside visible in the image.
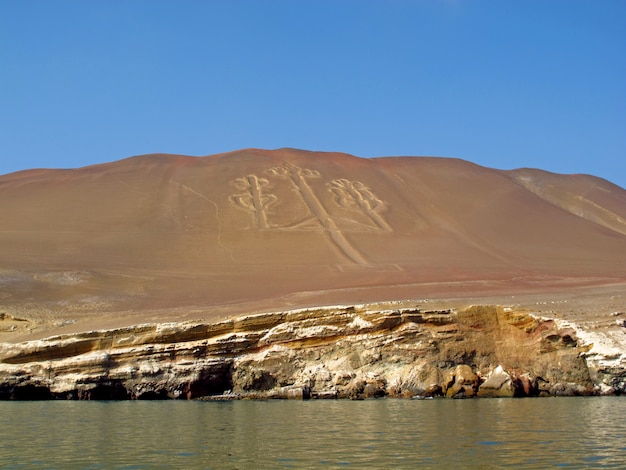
[229,163,392,266]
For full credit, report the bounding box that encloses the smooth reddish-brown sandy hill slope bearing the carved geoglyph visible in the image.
[0,149,626,336]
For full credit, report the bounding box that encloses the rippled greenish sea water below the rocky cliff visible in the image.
[0,397,626,469]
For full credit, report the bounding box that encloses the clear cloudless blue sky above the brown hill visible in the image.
[0,0,626,187]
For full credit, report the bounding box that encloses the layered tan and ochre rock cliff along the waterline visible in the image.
[0,306,626,399]
